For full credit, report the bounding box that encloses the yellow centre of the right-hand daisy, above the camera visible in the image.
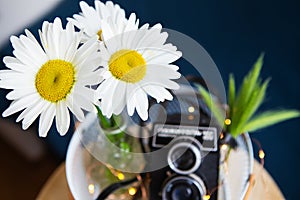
[108,49,146,83]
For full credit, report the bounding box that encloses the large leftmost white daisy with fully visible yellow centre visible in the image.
[0,18,102,137]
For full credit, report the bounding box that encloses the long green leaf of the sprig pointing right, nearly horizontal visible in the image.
[242,110,300,133]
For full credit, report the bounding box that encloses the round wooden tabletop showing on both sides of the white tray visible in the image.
[37,161,284,200]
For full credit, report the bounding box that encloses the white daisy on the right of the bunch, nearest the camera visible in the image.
[97,24,182,120]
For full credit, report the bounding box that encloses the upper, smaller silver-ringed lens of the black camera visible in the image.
[167,136,201,175]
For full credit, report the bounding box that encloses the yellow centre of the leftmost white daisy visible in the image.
[35,59,75,103]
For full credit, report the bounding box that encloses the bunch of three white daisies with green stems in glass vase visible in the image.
[0,0,182,198]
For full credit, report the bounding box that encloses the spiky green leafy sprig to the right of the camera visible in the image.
[199,54,300,138]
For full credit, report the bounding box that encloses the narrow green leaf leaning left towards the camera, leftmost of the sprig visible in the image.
[198,85,225,127]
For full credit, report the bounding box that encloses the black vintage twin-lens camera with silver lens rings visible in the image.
[149,85,220,200]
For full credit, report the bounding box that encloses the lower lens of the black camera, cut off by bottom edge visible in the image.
[162,174,206,200]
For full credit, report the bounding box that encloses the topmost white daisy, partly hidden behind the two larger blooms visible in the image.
[67,0,138,41]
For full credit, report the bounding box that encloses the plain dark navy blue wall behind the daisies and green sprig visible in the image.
[0,0,300,199]
